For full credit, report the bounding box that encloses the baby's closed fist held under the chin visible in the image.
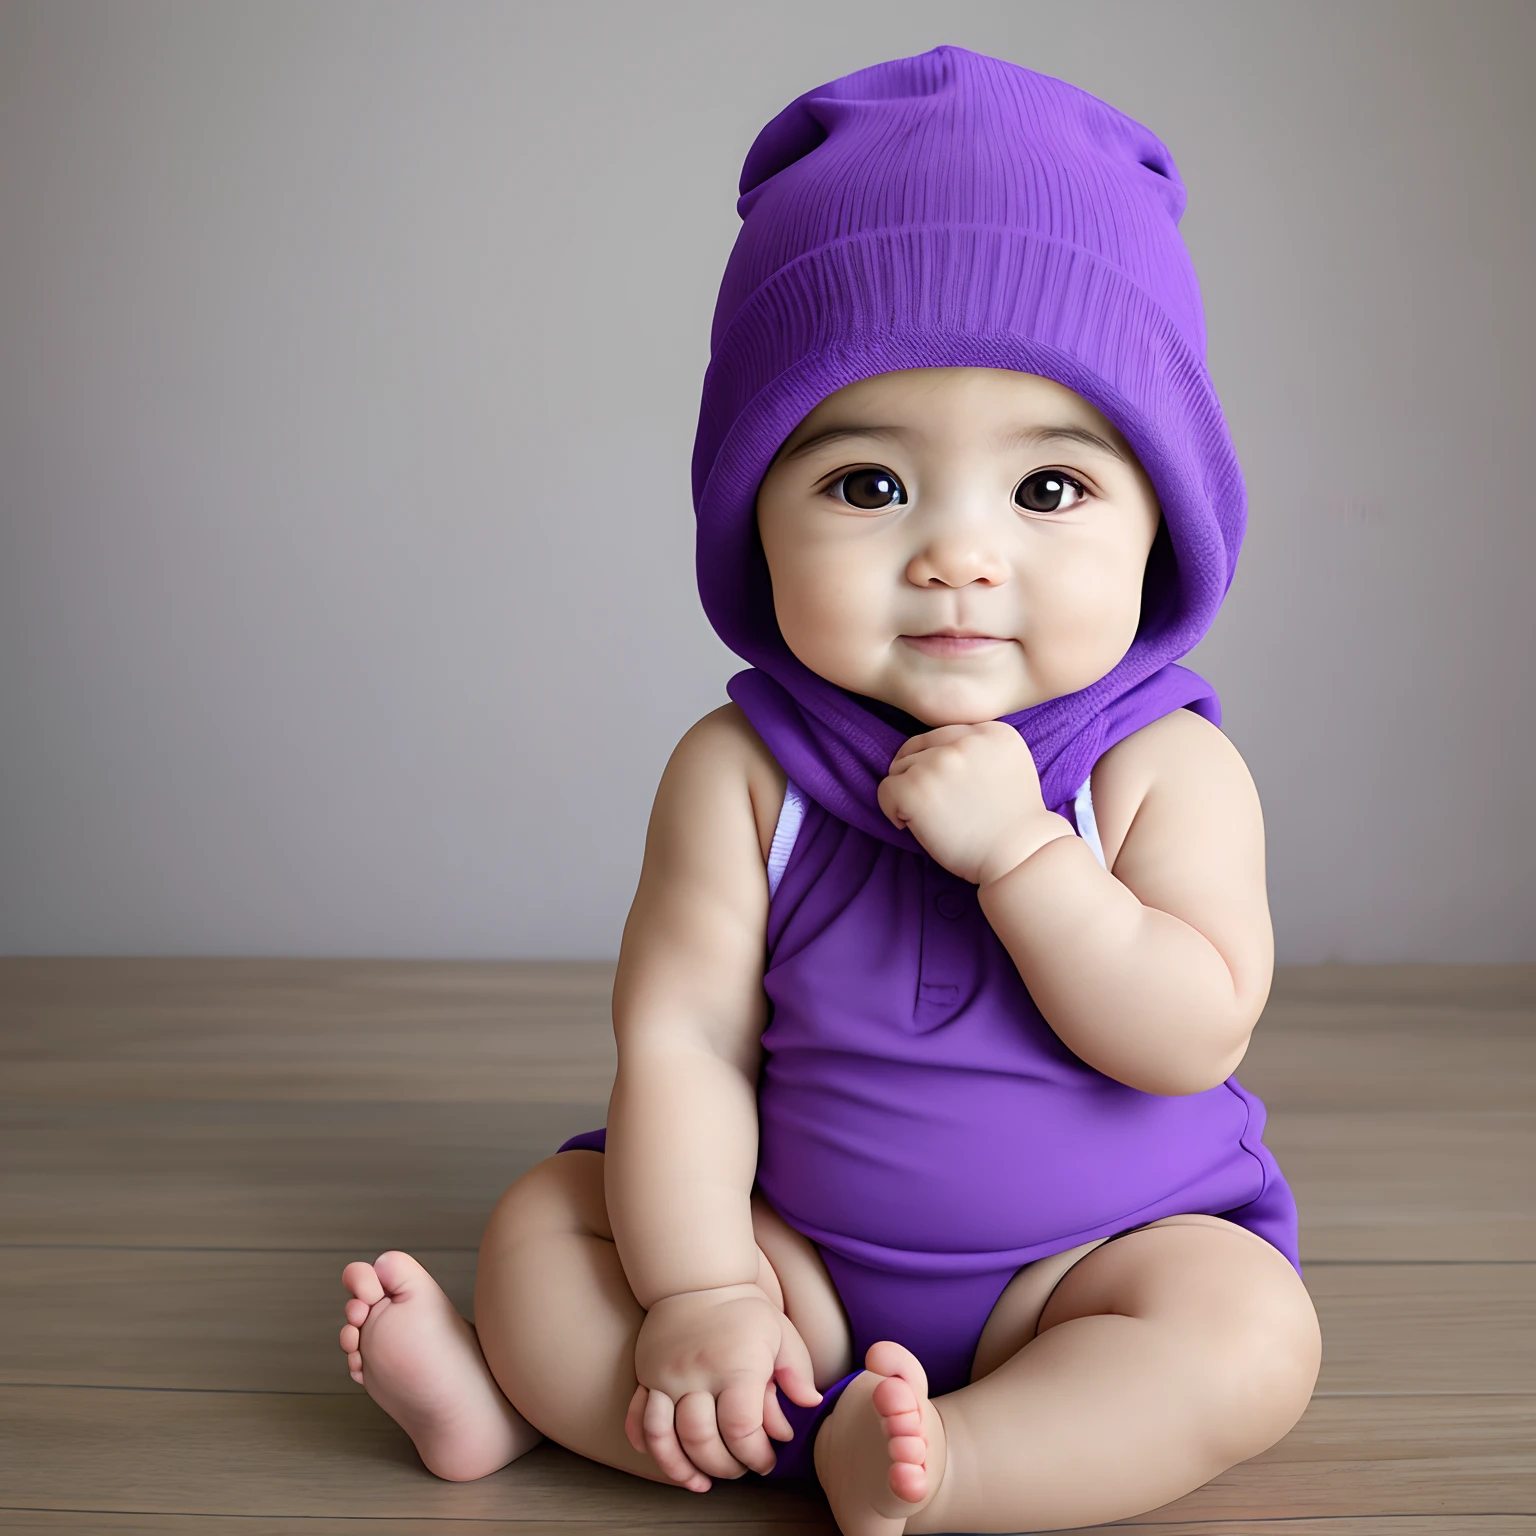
[879,720,1072,885]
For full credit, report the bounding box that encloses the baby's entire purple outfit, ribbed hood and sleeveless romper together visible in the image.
[561,48,1301,1476]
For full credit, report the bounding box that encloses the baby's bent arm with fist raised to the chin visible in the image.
[886,710,1275,1094]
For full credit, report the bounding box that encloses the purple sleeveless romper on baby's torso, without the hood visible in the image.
[561,715,1301,1476]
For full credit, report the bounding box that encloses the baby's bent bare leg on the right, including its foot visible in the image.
[816,1217,1321,1536]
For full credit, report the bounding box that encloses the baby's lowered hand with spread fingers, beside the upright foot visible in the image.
[624,1286,822,1493]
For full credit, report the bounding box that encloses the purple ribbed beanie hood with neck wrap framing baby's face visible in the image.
[693,48,1247,849]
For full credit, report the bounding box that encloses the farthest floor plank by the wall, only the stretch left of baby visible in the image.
[0,957,616,1103]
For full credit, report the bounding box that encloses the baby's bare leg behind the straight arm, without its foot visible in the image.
[475,1150,849,1482]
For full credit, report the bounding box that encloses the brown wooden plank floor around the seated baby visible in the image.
[0,958,1536,1536]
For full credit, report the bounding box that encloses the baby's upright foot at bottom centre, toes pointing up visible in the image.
[814,1339,945,1536]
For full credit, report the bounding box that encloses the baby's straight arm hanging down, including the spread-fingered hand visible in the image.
[604,705,817,1485]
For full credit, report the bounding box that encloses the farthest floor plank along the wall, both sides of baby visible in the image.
[0,957,1536,1111]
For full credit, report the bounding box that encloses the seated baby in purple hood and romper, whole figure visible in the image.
[341,48,1321,1536]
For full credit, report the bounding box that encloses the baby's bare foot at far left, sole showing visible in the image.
[341,1253,542,1482]
